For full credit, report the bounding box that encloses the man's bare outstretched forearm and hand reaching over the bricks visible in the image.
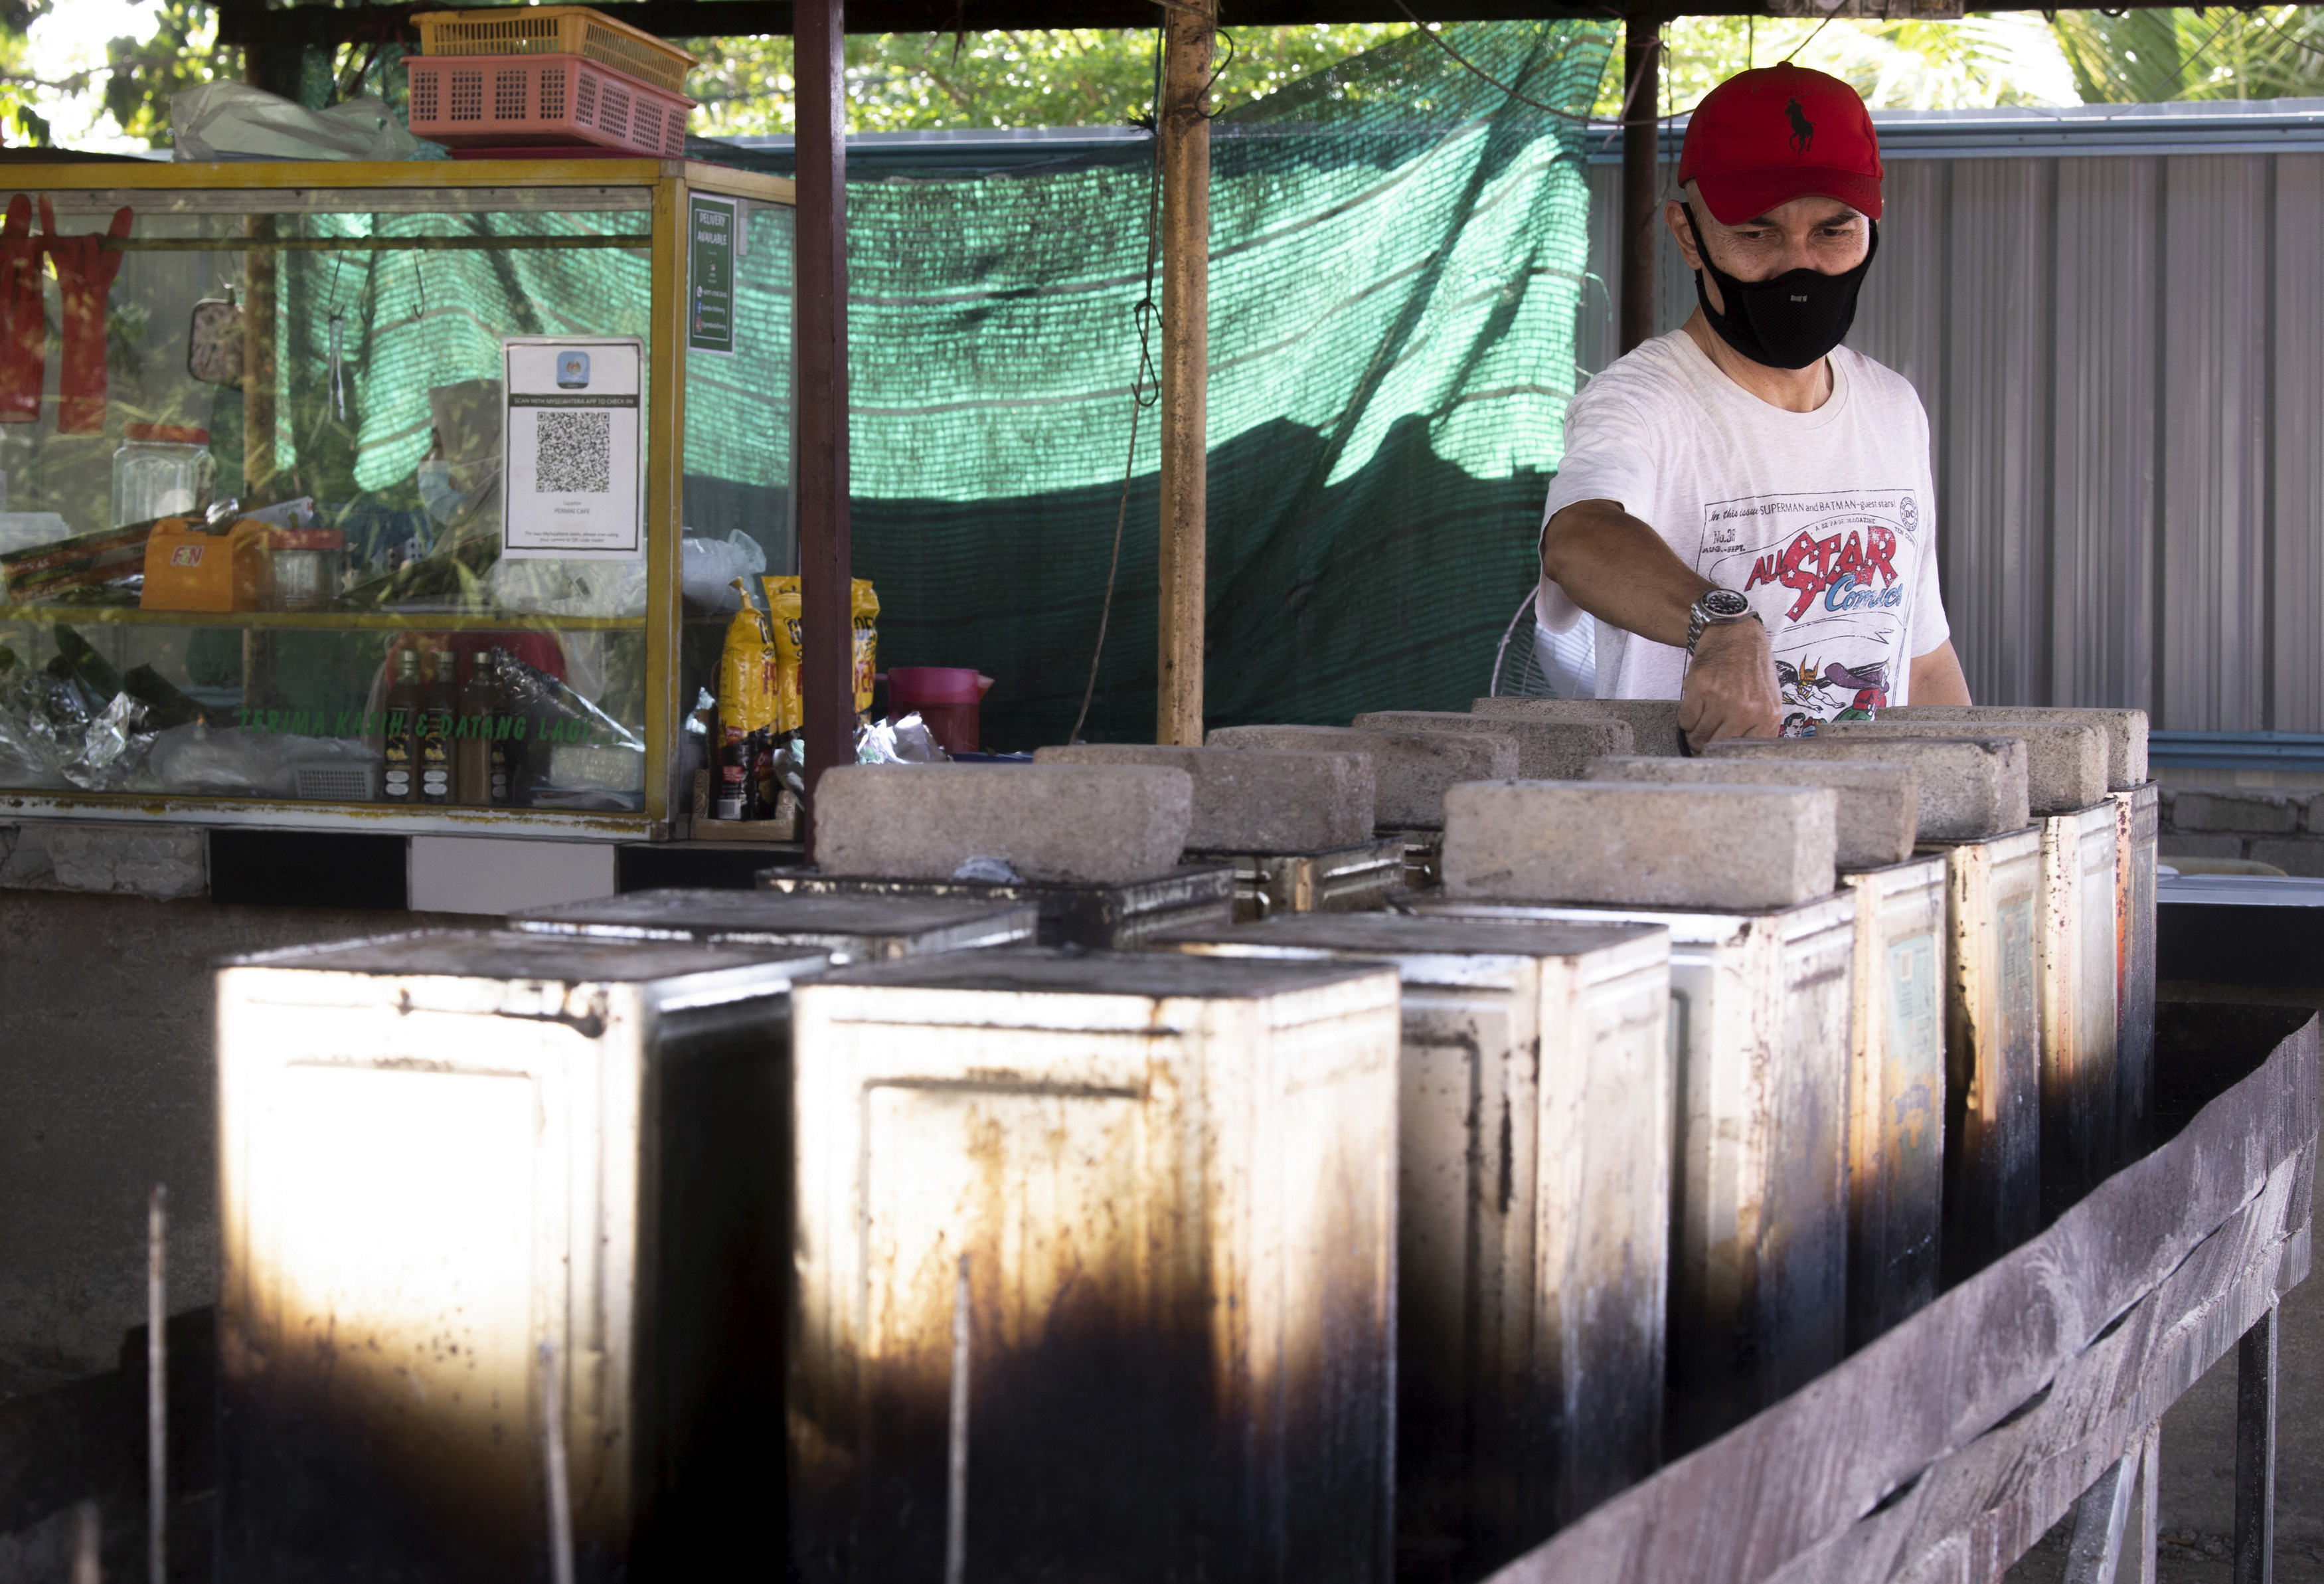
[1541,500,1776,749]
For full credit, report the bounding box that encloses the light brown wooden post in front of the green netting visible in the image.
[1155,0,1218,745]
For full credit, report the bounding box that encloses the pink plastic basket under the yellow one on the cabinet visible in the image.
[404,56,695,158]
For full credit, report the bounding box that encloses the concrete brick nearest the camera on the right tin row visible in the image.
[1444,782,1841,909]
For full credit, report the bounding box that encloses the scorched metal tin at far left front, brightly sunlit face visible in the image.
[218,930,827,1584]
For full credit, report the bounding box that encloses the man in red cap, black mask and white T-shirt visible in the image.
[1536,63,1969,747]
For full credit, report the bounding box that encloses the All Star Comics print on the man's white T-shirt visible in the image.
[1697,488,1924,733]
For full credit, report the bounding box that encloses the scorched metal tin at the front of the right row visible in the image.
[790,951,1399,1584]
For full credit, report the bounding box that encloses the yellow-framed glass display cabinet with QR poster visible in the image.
[0,158,795,839]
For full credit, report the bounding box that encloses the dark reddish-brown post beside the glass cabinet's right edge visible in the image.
[793,0,855,851]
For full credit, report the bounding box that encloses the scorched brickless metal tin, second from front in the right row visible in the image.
[1155,914,1676,1577]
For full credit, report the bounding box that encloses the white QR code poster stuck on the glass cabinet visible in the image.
[500,337,646,561]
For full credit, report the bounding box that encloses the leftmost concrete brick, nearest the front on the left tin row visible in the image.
[813,765,1195,886]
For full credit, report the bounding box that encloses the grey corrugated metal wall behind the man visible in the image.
[1578,120,2324,733]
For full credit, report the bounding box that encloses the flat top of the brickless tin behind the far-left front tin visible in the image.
[509,889,1039,963]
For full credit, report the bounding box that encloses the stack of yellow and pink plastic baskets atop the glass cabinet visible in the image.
[404,5,695,158]
